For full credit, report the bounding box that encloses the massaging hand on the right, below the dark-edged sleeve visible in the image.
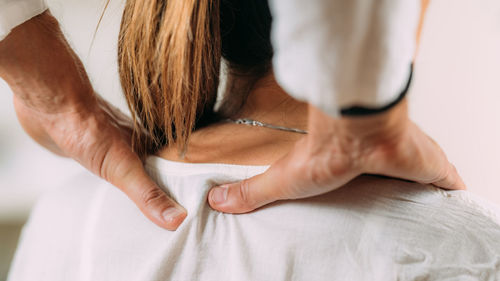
[208,101,465,213]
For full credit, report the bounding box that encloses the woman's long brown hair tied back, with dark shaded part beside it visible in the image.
[118,0,272,155]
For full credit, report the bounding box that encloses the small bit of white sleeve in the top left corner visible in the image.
[0,0,47,40]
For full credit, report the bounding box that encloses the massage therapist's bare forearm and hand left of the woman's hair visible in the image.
[0,12,187,230]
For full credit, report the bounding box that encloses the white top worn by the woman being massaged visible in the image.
[8,157,500,281]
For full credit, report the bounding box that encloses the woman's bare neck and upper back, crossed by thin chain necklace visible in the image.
[158,72,307,165]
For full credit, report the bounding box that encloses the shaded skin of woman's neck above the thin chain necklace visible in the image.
[231,74,307,130]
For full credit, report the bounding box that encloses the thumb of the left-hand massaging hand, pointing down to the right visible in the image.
[103,143,187,230]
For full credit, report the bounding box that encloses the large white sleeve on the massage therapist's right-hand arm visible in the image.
[270,0,420,116]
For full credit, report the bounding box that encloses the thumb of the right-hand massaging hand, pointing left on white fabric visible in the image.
[208,165,285,214]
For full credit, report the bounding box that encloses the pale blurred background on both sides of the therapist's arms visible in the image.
[0,0,500,280]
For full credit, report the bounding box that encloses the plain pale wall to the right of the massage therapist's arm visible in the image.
[410,0,500,201]
